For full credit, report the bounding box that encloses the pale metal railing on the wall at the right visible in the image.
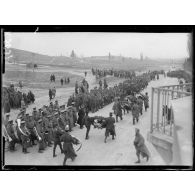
[150,83,192,136]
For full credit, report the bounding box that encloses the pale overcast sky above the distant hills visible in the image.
[5,33,188,58]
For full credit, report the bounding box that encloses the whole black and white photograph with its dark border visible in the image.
[1,26,194,170]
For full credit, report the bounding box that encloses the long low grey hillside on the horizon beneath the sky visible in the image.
[5,48,186,70]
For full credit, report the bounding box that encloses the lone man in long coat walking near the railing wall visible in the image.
[134,128,150,163]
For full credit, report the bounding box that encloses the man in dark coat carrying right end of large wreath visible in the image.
[104,112,116,143]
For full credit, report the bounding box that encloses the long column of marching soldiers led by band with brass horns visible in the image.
[4,69,163,164]
